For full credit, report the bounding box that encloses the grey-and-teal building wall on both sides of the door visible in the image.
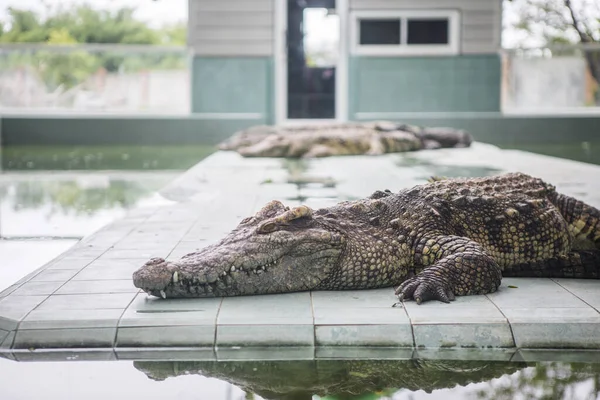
[188,0,501,118]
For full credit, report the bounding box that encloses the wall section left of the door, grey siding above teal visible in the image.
[188,0,275,117]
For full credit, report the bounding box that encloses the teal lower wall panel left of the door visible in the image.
[191,56,274,122]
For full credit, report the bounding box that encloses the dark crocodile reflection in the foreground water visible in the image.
[134,359,600,400]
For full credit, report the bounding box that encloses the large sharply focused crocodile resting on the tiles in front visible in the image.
[133,172,600,304]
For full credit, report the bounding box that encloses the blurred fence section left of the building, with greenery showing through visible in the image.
[0,44,190,114]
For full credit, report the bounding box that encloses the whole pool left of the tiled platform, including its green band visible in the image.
[0,145,215,290]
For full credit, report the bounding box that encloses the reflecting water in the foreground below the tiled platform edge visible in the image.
[0,356,600,400]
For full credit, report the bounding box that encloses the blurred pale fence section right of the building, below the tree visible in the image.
[502,44,600,113]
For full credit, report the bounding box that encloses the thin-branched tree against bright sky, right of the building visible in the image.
[508,0,600,82]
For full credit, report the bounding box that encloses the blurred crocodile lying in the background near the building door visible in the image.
[219,121,472,158]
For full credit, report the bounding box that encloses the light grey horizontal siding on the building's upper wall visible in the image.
[188,0,502,56]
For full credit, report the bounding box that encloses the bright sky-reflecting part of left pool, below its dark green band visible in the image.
[0,171,180,290]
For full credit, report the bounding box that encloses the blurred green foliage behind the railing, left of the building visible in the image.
[0,5,187,90]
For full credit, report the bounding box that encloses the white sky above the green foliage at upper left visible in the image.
[0,0,188,27]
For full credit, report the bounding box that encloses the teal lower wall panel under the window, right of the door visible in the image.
[349,54,501,115]
